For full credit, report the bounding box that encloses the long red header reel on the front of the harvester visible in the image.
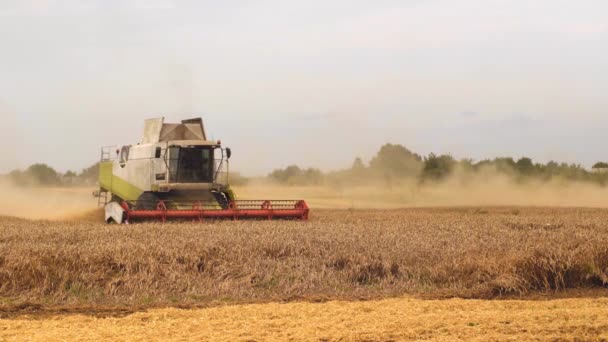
[121,200,310,222]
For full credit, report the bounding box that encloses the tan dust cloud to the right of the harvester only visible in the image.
[237,172,608,209]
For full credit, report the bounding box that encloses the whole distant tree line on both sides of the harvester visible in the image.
[5,144,608,186]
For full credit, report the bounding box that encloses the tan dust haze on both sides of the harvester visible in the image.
[0,173,608,221]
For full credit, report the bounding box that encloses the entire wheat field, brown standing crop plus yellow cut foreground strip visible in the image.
[0,207,608,341]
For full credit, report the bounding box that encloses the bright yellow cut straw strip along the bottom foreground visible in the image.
[0,298,608,341]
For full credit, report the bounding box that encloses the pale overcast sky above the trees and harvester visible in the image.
[0,0,608,175]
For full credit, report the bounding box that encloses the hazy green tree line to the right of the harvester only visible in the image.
[267,144,608,186]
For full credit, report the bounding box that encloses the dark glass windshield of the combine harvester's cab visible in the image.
[169,146,214,183]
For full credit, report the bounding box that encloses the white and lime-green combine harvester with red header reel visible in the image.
[95,118,309,224]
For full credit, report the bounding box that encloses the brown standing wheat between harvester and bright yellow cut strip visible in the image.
[0,208,608,309]
